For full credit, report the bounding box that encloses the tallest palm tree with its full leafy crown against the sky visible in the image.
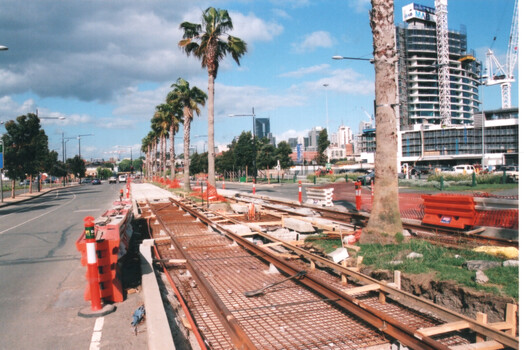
[178,7,247,186]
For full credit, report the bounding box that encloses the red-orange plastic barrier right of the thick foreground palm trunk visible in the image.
[421,194,477,229]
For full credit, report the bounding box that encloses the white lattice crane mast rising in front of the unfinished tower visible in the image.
[435,0,451,126]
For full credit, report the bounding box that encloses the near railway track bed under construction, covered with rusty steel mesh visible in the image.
[138,199,518,349]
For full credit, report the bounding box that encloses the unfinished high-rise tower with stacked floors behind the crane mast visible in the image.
[397,3,481,130]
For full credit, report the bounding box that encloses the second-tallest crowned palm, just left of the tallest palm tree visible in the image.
[166,78,207,192]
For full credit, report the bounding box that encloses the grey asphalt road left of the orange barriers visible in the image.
[0,184,147,349]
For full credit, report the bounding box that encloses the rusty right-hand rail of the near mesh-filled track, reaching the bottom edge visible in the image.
[169,199,449,349]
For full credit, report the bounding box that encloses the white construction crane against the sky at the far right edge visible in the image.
[485,0,519,109]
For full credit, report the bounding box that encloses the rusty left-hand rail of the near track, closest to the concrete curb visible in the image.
[147,201,256,349]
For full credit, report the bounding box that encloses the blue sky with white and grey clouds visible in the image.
[0,0,518,159]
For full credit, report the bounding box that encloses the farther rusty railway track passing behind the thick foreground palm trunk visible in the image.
[226,194,519,248]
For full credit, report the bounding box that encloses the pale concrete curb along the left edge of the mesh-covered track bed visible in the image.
[140,239,176,350]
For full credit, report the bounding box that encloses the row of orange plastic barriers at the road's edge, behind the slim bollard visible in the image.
[76,201,133,302]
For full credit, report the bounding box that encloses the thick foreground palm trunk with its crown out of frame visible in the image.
[360,0,402,244]
